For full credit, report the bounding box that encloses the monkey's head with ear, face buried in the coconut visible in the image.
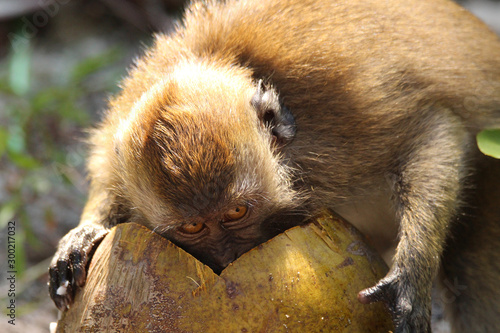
[115,63,300,272]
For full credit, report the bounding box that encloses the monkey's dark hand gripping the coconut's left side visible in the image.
[49,224,109,311]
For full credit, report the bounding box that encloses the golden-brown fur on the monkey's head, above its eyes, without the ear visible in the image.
[104,63,298,228]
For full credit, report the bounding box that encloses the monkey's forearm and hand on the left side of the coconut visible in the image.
[49,185,116,310]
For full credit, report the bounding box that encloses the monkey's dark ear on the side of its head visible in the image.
[251,80,296,147]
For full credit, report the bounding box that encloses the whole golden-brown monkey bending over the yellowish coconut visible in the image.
[49,0,500,333]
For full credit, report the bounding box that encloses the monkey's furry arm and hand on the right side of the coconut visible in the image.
[358,113,470,333]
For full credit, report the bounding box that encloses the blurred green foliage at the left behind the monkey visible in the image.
[0,32,124,273]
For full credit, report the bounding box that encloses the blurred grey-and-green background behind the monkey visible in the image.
[0,0,500,333]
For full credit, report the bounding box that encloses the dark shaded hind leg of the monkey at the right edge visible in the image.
[437,156,500,333]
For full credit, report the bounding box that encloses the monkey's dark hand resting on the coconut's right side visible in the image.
[358,265,432,333]
